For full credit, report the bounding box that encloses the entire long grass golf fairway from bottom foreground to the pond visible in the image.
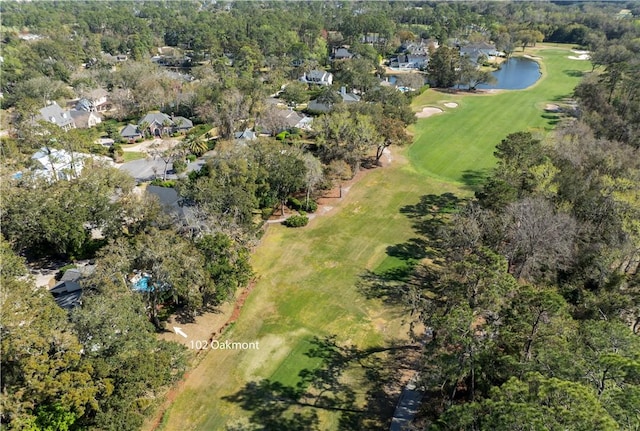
[154,42,590,431]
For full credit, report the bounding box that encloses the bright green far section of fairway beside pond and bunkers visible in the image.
[409,45,591,183]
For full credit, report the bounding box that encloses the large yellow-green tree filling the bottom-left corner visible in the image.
[0,277,99,429]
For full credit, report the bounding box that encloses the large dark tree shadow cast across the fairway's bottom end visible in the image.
[223,336,421,431]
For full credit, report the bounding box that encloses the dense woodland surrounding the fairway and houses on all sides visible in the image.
[0,1,640,431]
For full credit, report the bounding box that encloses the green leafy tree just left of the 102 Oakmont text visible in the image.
[70,286,187,431]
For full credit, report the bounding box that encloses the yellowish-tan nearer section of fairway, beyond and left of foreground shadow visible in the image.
[156,162,459,430]
